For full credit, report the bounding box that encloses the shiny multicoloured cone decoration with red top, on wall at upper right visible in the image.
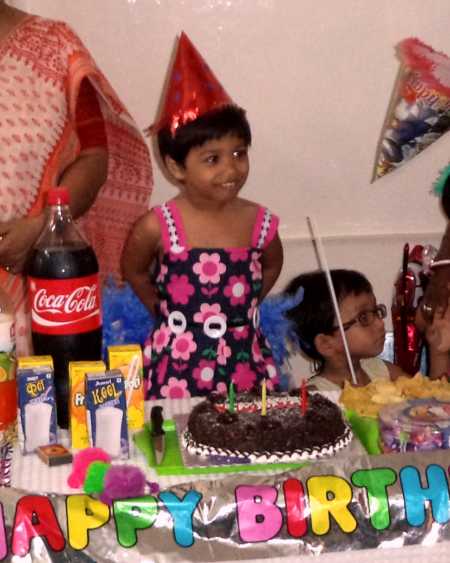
[373,38,450,179]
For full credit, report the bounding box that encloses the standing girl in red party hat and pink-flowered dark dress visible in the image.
[119,34,283,398]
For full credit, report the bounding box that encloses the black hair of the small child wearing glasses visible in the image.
[285,269,373,372]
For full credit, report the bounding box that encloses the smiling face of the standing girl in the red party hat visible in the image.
[169,135,249,203]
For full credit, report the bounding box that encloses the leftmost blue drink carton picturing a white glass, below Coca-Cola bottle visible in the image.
[17,365,57,453]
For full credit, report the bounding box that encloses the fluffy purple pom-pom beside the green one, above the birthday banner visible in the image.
[100,465,146,506]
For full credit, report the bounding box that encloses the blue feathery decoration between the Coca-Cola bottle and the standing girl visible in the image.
[102,278,155,357]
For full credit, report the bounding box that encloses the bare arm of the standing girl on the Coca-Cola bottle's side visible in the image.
[121,211,161,314]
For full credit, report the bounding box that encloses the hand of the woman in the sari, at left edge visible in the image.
[0,215,45,273]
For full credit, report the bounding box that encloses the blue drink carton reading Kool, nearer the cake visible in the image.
[86,369,129,459]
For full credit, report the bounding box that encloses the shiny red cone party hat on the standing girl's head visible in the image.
[151,31,233,135]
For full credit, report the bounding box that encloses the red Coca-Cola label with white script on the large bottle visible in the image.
[28,274,102,334]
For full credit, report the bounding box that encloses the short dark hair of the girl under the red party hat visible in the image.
[158,105,252,166]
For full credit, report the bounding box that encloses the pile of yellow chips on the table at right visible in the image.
[340,373,450,418]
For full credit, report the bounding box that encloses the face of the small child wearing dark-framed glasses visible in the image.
[339,293,386,358]
